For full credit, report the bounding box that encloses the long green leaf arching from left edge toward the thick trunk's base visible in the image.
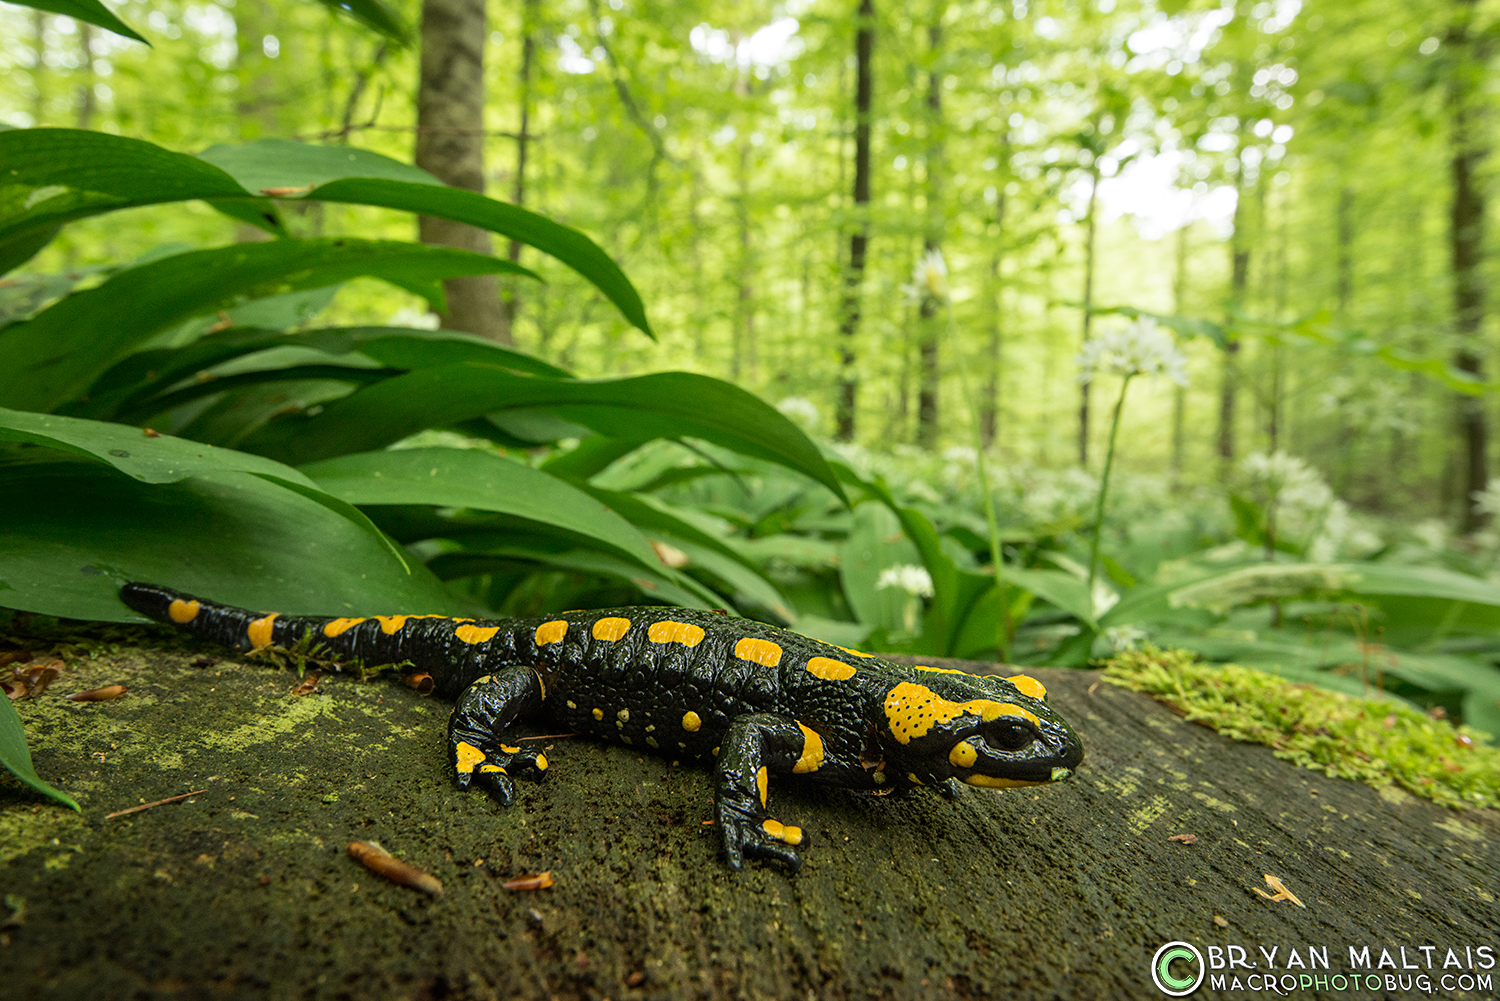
[0,240,530,410]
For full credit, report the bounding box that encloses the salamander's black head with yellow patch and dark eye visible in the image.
[882,668,1083,788]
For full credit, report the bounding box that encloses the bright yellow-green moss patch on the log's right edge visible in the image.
[1104,647,1500,809]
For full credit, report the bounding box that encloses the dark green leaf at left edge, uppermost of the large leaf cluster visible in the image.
[0,129,252,275]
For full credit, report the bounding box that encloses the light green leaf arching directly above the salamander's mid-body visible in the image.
[303,449,662,572]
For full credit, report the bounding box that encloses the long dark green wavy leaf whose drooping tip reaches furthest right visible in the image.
[246,363,843,497]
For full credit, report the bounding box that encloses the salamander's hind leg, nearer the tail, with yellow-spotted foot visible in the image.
[449,668,548,806]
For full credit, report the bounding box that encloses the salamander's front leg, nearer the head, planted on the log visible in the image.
[714,713,822,872]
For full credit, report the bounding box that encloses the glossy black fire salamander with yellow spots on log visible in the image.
[120,584,1083,869]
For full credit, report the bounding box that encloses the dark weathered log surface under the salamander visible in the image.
[0,629,1500,1001]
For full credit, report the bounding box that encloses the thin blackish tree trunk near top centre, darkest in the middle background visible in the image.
[836,0,875,441]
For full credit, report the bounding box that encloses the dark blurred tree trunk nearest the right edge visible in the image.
[1448,0,1493,533]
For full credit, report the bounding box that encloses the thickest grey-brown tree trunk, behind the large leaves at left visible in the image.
[417,0,512,344]
